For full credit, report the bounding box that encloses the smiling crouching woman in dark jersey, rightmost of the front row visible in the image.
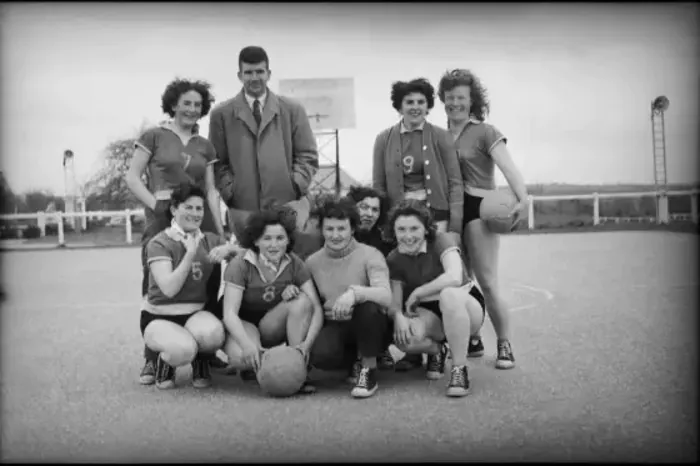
[387,200,486,396]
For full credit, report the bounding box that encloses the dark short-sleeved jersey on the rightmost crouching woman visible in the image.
[386,232,469,299]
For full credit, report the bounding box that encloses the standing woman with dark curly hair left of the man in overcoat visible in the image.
[126,79,230,385]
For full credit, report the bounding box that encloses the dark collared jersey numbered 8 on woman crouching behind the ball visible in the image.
[224,249,311,314]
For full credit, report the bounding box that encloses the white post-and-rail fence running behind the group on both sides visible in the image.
[0,190,700,246]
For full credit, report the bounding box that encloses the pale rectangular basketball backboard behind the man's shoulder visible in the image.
[279,78,355,131]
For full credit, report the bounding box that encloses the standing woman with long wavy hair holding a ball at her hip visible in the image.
[438,69,527,369]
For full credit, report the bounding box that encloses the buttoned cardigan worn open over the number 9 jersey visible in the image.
[372,122,464,236]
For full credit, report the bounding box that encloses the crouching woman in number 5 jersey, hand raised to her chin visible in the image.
[141,184,237,389]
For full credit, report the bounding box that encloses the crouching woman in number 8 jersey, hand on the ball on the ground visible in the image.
[224,208,323,393]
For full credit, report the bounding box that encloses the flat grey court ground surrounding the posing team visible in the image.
[1,232,698,462]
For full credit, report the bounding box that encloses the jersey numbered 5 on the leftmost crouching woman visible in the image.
[146,227,223,312]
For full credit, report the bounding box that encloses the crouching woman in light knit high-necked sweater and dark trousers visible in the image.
[306,198,391,398]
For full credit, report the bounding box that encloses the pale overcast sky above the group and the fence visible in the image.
[0,3,700,193]
